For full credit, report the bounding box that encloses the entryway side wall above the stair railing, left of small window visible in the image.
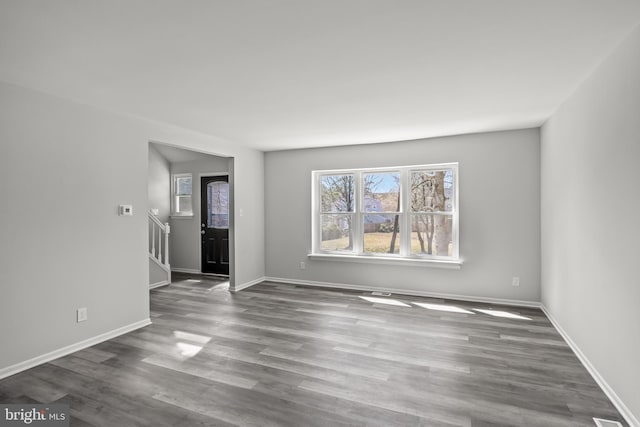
[148,144,171,224]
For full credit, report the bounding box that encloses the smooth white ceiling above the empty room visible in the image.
[0,0,640,151]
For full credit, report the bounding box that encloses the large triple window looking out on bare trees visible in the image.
[312,163,458,262]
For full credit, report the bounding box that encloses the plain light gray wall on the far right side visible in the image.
[541,27,640,425]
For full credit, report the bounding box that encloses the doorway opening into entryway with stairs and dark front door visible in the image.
[148,142,235,288]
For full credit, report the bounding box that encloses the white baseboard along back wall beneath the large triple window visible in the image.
[264,277,540,308]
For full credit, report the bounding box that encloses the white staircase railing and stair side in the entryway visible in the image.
[148,212,171,289]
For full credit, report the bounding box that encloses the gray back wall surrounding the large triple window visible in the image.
[265,129,540,301]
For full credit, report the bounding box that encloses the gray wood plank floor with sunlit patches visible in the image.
[0,274,626,427]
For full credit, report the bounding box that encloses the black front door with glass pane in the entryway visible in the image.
[200,175,229,274]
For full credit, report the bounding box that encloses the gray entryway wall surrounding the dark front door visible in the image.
[169,154,229,272]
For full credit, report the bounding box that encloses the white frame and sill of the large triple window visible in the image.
[309,162,462,268]
